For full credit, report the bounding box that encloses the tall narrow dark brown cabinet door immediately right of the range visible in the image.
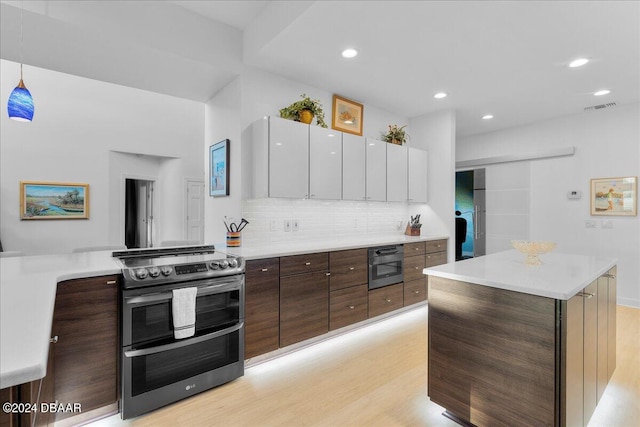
[244,258,280,359]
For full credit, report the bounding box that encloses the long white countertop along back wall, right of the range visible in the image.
[215,233,449,260]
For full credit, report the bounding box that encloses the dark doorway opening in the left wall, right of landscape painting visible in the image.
[124,178,154,249]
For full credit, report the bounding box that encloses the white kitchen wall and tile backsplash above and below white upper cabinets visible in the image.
[205,67,453,244]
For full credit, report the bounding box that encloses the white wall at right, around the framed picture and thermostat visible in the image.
[456,104,640,307]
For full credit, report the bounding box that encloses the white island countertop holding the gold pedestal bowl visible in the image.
[423,249,617,300]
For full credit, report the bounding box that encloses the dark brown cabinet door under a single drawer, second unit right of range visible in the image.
[280,270,329,347]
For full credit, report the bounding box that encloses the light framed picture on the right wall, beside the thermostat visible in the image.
[590,176,638,216]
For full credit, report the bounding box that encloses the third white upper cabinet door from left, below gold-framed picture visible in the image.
[342,133,366,201]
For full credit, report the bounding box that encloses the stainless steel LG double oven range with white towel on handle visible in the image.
[113,246,245,419]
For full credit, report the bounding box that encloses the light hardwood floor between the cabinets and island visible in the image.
[92,306,640,427]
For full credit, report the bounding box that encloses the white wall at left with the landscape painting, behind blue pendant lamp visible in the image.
[0,60,204,254]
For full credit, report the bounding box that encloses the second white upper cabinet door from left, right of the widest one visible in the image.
[309,126,342,200]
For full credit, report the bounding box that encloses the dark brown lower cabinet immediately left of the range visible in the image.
[52,276,119,421]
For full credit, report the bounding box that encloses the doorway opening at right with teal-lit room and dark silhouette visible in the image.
[455,169,486,261]
